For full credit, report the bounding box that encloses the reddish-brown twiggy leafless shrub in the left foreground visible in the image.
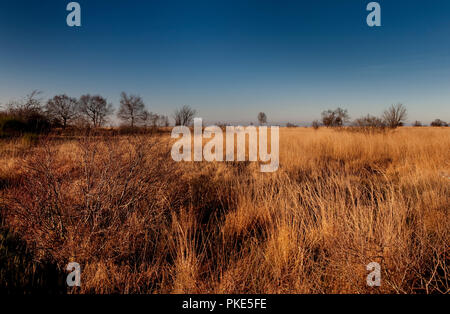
[3,138,182,292]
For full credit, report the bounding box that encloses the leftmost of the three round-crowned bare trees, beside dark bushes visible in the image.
[45,94,78,129]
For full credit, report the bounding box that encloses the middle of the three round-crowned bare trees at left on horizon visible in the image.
[79,94,114,128]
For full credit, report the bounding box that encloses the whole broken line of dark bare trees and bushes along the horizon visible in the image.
[0,91,448,135]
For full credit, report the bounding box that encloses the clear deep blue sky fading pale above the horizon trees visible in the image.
[0,0,450,123]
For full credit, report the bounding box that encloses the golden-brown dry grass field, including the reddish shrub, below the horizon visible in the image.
[0,127,450,293]
